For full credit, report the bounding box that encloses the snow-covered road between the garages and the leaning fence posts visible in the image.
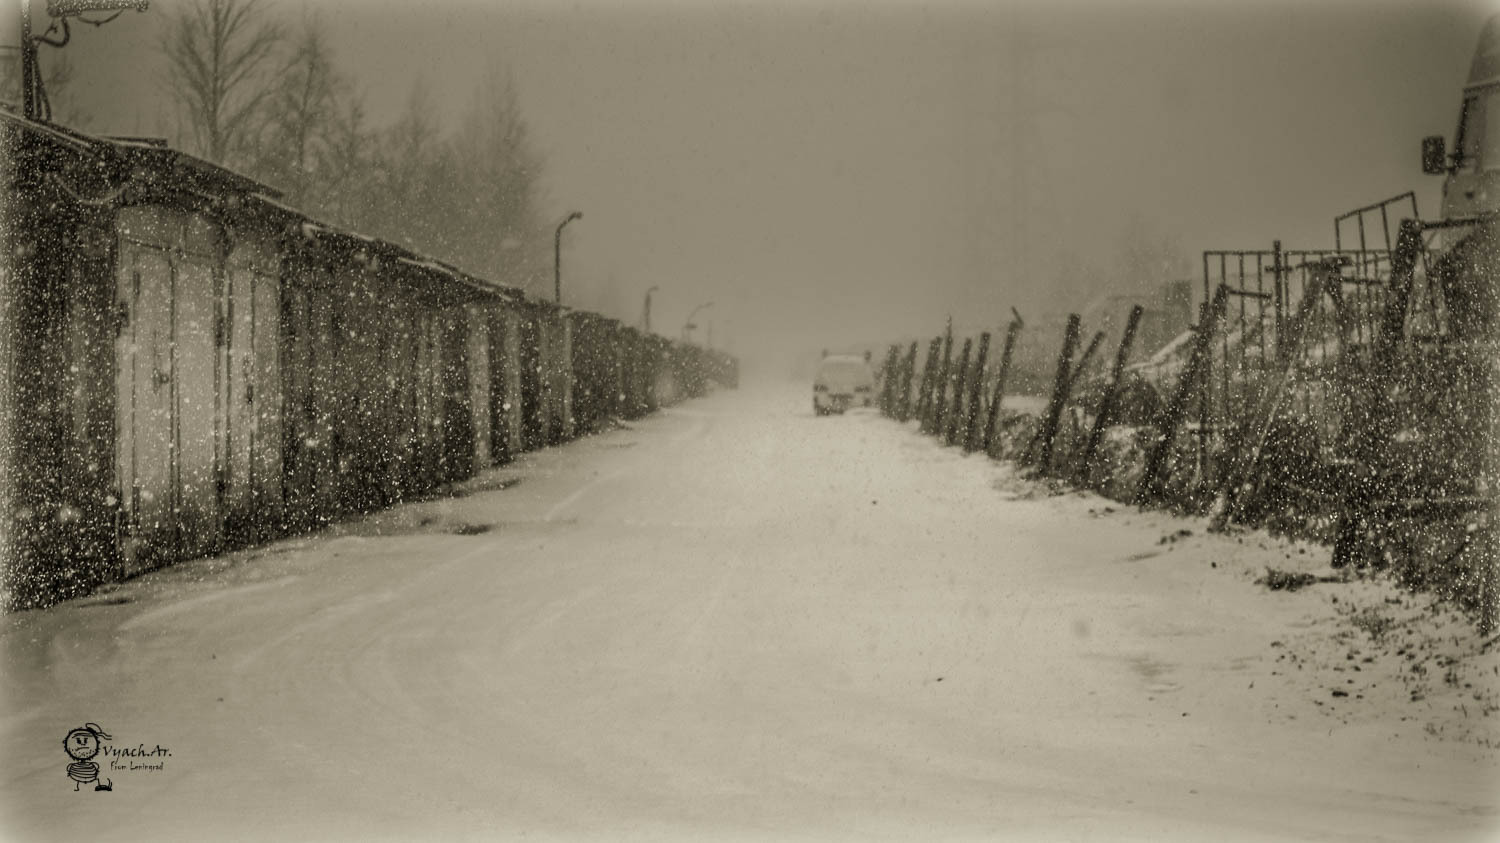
[0,386,1500,840]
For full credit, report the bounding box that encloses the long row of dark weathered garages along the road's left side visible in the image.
[0,113,735,608]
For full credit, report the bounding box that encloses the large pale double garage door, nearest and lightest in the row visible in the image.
[114,206,282,573]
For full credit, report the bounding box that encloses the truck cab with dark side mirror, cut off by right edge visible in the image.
[1422,15,1500,219]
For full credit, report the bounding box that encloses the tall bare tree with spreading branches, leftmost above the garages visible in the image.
[161,0,285,165]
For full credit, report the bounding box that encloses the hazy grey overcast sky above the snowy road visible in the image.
[11,0,1500,367]
